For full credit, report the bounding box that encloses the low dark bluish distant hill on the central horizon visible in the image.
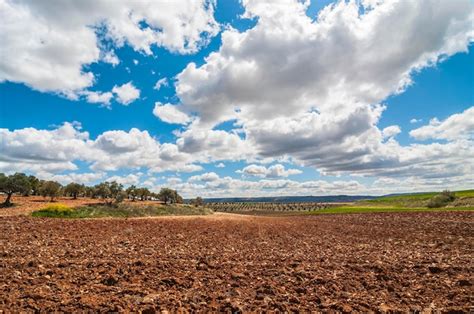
[204,195,377,203]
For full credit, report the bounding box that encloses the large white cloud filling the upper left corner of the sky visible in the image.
[0,0,219,98]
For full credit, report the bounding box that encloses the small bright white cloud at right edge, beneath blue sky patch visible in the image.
[410,107,474,140]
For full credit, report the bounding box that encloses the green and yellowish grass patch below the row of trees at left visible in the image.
[31,204,212,218]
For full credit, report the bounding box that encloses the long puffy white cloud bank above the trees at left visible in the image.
[0,122,202,174]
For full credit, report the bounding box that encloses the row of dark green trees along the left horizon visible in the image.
[0,173,184,206]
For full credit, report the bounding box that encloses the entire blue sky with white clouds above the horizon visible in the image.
[0,0,474,197]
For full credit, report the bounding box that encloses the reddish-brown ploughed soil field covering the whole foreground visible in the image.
[0,212,474,313]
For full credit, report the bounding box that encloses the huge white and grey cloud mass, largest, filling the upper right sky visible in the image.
[168,0,474,184]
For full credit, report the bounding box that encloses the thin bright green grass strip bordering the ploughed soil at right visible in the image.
[306,206,474,215]
